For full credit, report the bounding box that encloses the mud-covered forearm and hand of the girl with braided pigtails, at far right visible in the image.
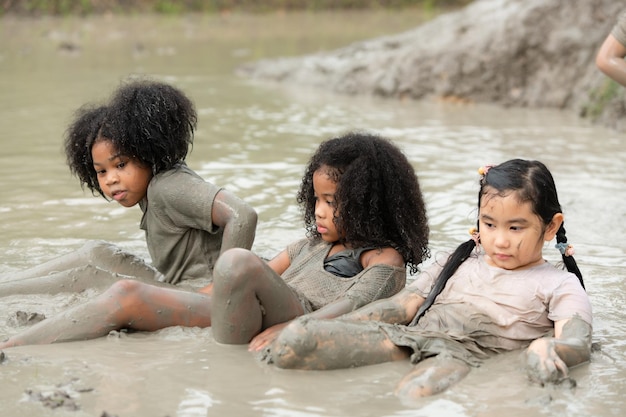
[526,316,591,383]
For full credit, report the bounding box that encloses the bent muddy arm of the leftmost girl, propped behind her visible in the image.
[211,190,257,253]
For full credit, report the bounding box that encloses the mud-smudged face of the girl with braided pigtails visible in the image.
[478,189,551,270]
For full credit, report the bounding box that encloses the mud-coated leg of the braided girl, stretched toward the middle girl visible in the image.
[270,317,409,370]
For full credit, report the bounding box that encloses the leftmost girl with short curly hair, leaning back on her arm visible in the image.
[0,80,257,296]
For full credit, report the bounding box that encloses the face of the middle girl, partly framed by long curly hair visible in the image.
[313,170,339,243]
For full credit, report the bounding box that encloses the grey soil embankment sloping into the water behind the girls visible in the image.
[238,0,626,131]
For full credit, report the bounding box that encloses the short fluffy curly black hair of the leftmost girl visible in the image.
[64,80,198,198]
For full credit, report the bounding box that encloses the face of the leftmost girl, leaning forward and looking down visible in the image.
[91,140,152,207]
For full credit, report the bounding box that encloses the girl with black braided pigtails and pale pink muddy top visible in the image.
[268,159,592,397]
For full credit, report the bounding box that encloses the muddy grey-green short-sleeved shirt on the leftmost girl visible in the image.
[139,164,223,284]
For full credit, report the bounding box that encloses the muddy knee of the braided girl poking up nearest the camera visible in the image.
[395,356,470,398]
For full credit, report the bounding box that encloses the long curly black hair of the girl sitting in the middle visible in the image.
[297,132,430,274]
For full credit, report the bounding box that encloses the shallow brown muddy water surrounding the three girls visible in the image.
[0,12,626,417]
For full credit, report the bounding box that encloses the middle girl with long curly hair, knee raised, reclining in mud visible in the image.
[0,133,429,350]
